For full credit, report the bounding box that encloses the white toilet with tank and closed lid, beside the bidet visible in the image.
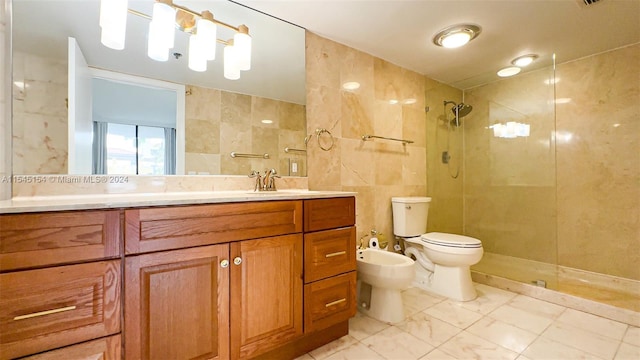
[391,197,483,301]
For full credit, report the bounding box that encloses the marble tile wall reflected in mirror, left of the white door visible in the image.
[12,52,68,174]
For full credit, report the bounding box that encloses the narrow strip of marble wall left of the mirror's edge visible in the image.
[0,0,11,200]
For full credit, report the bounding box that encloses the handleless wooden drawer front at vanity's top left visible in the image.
[0,210,120,271]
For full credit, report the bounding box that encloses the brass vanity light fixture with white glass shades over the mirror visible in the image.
[100,0,252,80]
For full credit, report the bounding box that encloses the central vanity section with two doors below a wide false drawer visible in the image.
[125,201,303,359]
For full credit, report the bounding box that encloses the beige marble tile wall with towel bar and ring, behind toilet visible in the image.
[306,32,427,245]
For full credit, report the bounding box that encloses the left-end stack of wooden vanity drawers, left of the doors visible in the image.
[0,210,122,360]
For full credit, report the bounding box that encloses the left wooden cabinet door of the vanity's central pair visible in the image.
[125,244,229,359]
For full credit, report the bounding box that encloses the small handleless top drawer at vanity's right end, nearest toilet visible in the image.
[304,197,356,232]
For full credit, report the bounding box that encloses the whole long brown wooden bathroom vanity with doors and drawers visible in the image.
[0,192,356,359]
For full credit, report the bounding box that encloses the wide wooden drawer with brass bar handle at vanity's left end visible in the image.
[0,260,121,359]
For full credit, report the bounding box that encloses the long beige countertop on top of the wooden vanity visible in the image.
[0,189,356,214]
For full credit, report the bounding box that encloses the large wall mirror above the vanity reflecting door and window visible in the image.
[11,0,306,176]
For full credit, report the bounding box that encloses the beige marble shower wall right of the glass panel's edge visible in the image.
[556,44,640,280]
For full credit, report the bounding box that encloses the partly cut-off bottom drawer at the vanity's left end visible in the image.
[22,335,122,360]
